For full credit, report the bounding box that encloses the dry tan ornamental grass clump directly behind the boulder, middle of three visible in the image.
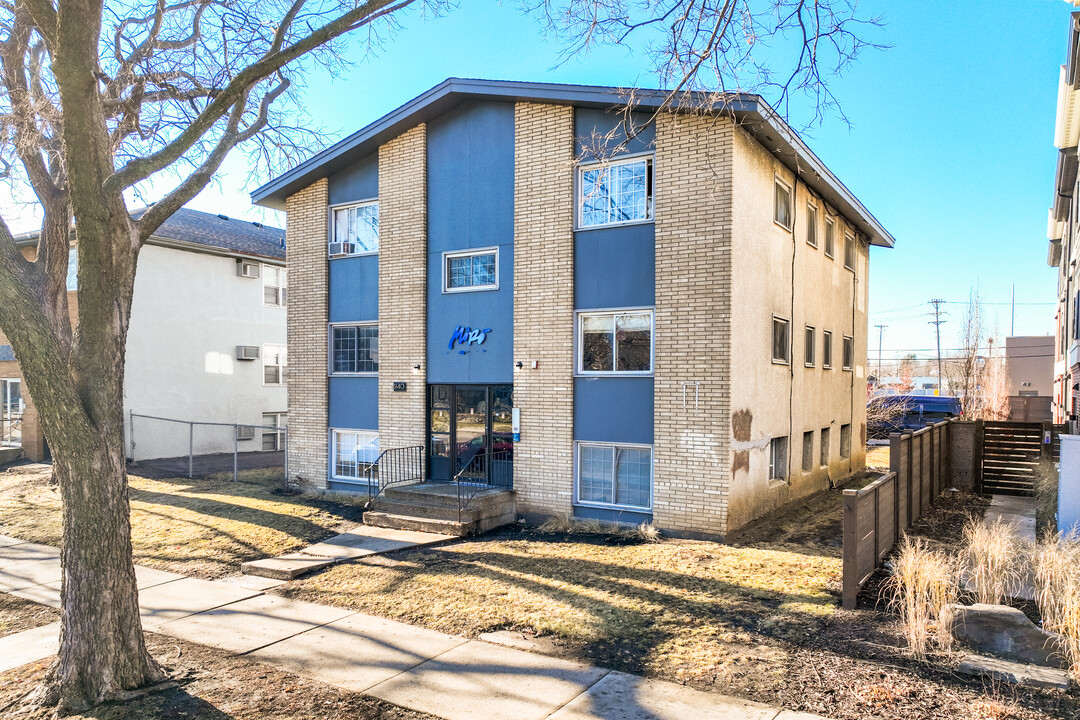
[960,518,1026,604]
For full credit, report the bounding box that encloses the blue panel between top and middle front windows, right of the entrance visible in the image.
[573,222,657,310]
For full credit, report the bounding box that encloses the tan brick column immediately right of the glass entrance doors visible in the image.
[514,103,573,514]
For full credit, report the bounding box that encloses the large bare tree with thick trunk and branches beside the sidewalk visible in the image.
[0,0,877,711]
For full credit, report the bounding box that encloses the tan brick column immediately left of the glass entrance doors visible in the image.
[379,124,428,459]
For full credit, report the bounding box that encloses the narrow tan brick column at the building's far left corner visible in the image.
[285,180,329,488]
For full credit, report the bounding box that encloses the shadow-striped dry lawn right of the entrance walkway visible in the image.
[280,548,836,675]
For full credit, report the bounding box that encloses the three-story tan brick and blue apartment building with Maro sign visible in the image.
[252,79,893,535]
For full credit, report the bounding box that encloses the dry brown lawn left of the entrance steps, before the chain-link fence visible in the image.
[0,465,362,579]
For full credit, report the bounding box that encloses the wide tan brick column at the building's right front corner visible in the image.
[653,114,732,534]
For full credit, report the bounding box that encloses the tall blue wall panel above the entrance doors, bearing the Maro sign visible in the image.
[427,103,514,383]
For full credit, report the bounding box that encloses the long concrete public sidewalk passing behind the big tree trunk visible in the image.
[0,535,821,720]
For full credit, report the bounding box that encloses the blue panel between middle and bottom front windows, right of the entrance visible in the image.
[573,377,652,445]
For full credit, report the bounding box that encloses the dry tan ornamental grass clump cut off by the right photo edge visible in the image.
[1031,533,1080,679]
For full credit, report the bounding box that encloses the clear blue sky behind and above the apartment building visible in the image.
[12,0,1072,357]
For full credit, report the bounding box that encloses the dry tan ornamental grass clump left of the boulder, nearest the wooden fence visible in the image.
[882,535,957,660]
